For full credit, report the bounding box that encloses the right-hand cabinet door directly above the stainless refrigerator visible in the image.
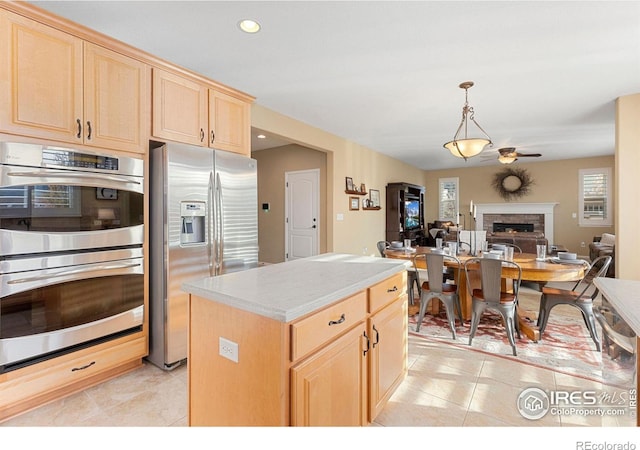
[209,89,251,156]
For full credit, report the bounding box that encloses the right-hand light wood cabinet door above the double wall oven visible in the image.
[84,43,150,153]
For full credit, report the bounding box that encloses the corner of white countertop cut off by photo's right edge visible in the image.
[593,277,640,336]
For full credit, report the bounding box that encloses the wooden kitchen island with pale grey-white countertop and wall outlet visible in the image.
[183,253,408,426]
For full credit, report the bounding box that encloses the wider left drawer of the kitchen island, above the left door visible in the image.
[291,291,367,362]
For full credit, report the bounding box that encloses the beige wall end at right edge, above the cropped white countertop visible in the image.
[615,94,640,280]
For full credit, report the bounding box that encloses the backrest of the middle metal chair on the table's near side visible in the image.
[464,258,522,303]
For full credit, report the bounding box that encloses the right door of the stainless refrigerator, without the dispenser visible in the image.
[212,151,258,275]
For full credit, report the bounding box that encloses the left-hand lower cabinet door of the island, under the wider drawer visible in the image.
[291,323,367,426]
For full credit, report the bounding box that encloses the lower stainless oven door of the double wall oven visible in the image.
[0,248,144,373]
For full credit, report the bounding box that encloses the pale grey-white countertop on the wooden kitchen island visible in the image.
[182,253,409,322]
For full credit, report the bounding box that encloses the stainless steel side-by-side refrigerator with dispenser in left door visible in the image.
[147,143,258,370]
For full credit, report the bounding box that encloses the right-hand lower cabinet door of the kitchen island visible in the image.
[368,294,408,421]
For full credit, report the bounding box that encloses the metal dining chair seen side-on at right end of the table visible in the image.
[538,255,612,351]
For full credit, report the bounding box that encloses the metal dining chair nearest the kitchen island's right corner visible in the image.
[413,253,463,339]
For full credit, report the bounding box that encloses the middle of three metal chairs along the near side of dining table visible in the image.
[464,258,522,356]
